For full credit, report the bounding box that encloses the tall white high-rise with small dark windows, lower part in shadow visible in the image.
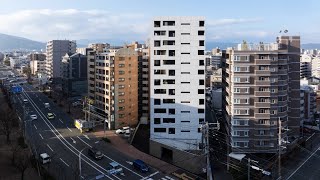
[150,17,205,151]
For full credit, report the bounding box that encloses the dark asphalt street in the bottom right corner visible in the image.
[286,147,320,180]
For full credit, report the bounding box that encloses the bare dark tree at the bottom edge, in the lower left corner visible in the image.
[15,150,32,180]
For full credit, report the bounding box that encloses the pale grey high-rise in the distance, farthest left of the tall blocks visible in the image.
[46,40,77,78]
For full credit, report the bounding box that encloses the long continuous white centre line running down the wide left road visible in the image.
[23,91,115,180]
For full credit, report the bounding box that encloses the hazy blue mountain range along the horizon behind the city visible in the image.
[0,33,320,51]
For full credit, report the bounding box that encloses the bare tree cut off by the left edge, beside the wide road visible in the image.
[0,106,16,144]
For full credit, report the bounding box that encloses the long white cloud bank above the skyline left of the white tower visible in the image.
[0,9,149,41]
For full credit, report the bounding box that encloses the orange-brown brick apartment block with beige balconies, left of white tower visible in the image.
[87,46,138,129]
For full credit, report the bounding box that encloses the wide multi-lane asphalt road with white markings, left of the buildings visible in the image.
[13,84,175,180]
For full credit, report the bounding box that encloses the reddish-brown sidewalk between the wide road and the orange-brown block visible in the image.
[92,127,179,174]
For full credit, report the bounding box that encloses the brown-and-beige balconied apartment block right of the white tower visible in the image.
[223,36,302,153]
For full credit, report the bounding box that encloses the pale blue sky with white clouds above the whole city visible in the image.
[0,0,320,43]
